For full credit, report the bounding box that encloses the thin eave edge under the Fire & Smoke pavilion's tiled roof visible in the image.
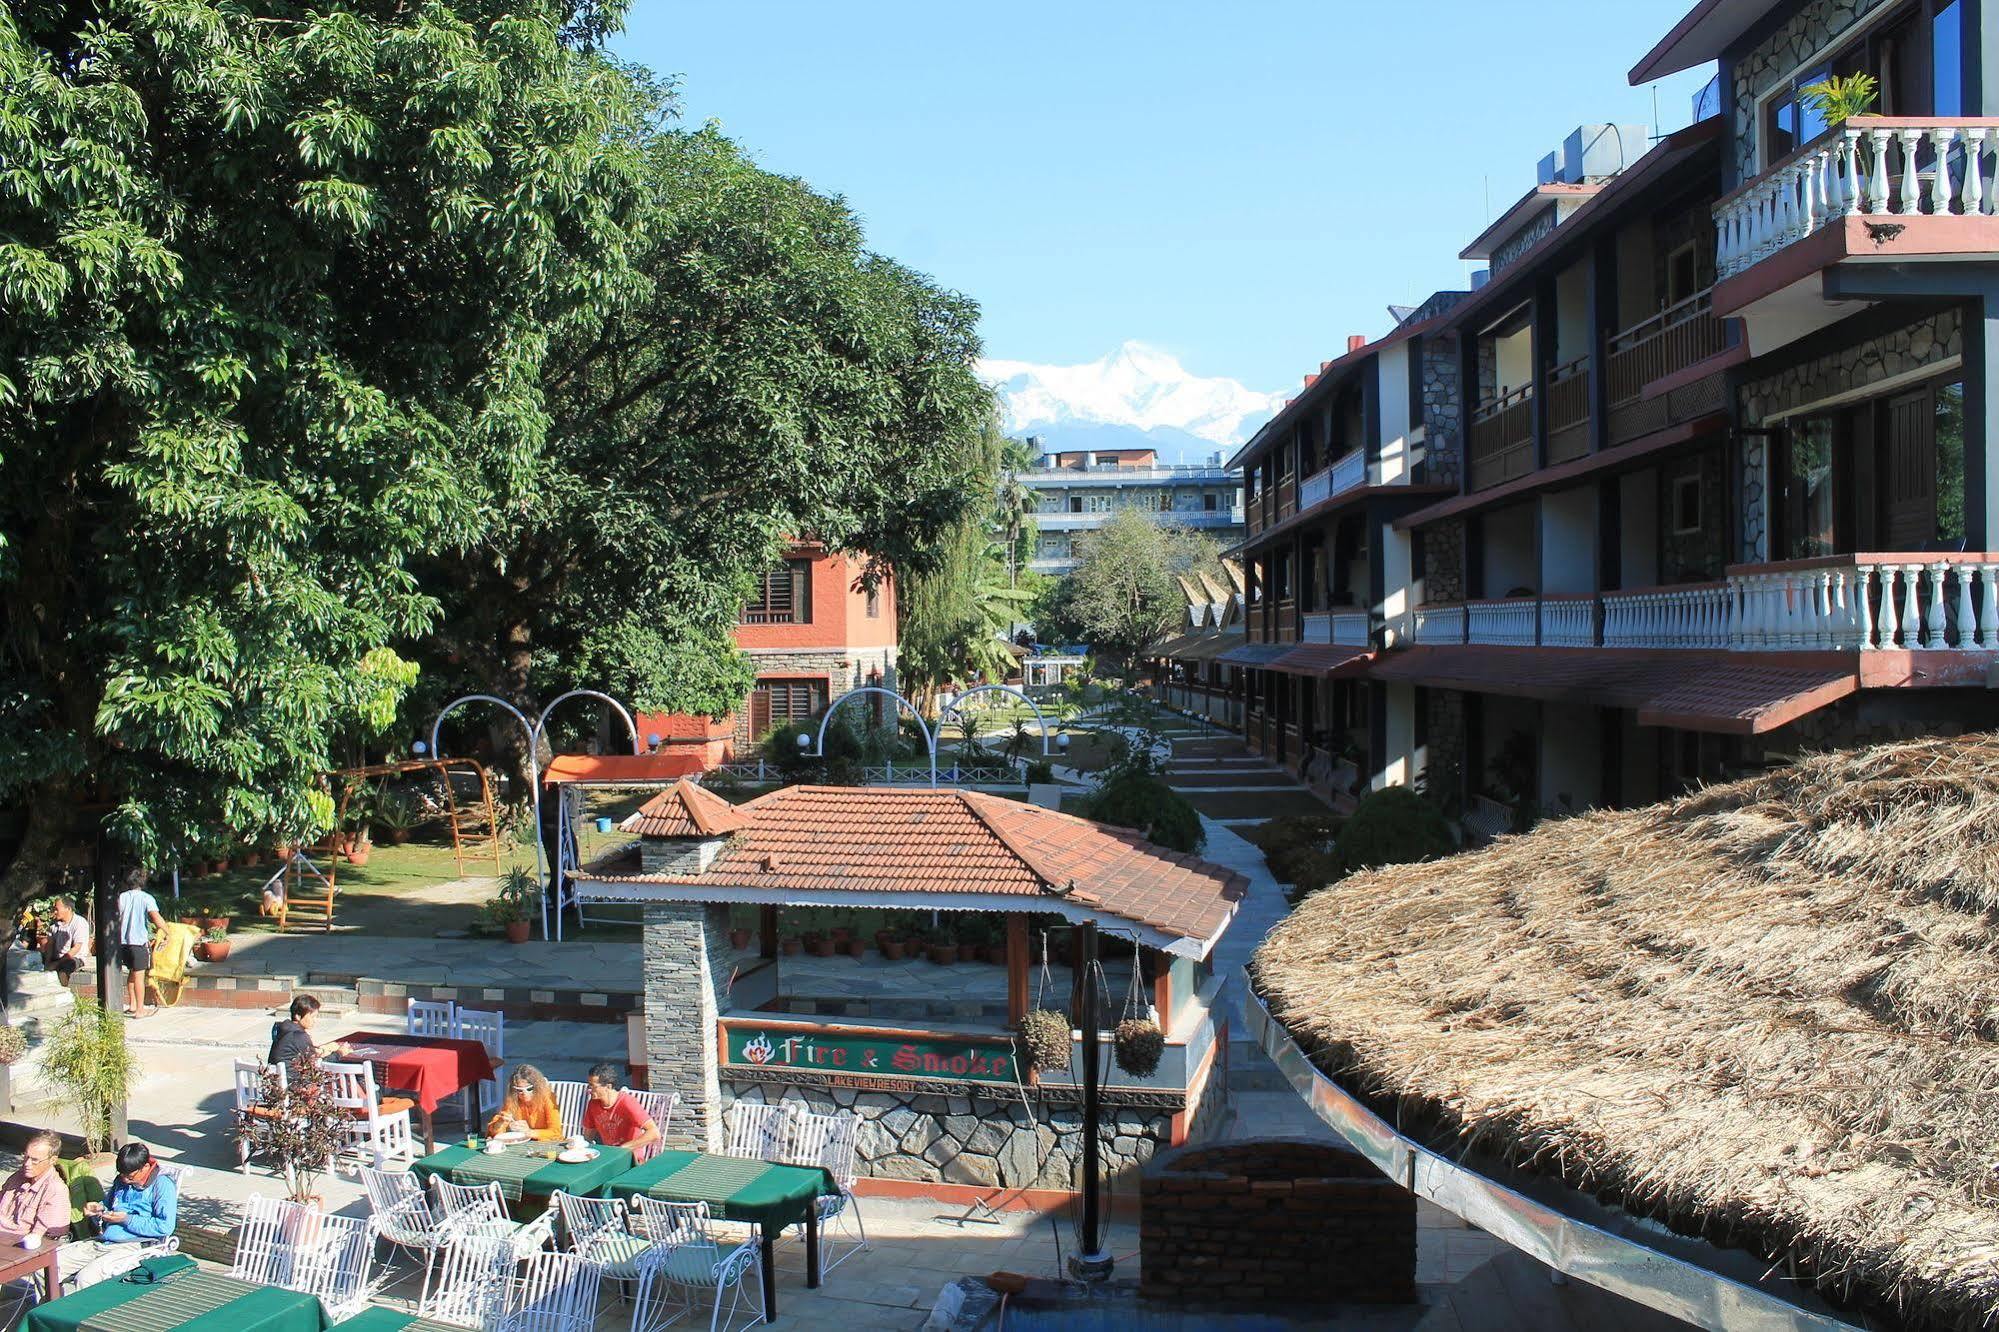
[570,872,1241,962]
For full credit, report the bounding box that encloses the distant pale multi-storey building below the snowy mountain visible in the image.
[1019,448,1243,574]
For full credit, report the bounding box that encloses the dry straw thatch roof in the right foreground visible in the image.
[1251,736,1999,1328]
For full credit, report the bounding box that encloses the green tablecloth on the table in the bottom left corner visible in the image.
[22,1254,332,1332]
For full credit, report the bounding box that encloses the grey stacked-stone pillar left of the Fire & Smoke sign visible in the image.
[642,902,730,1152]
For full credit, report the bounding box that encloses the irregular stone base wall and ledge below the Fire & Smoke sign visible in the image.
[722,1078,1175,1190]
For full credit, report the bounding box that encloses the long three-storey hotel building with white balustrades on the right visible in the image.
[1167,0,1999,830]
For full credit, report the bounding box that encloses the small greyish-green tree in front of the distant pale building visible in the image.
[1069,508,1221,680]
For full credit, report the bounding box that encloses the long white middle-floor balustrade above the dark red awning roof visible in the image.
[1415,552,1999,654]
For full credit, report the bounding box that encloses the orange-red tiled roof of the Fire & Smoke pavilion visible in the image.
[584,786,1249,944]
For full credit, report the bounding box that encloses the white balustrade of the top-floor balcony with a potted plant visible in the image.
[1715,116,1999,278]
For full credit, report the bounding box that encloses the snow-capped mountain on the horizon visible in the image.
[980,342,1283,462]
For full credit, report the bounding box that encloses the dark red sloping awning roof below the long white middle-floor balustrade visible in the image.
[1367,644,1859,734]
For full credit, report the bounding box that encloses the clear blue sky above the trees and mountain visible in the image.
[618,0,1709,390]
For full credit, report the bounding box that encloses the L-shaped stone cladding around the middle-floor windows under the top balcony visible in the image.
[1739,310,1965,562]
